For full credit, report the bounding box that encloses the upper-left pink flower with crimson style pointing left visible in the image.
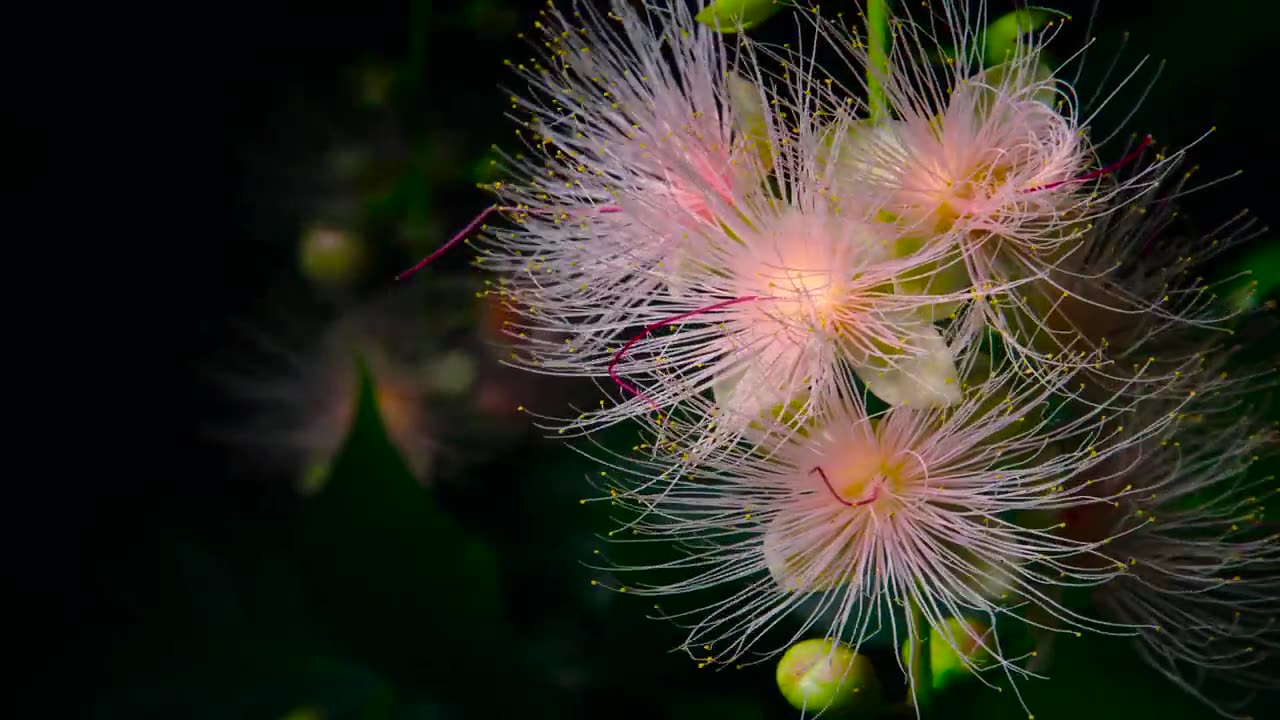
[476,1,767,392]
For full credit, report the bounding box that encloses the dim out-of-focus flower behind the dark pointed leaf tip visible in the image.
[215,292,445,495]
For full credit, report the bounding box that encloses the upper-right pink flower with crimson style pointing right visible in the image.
[798,1,1208,376]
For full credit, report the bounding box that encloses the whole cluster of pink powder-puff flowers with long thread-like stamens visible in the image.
[417,1,1277,712]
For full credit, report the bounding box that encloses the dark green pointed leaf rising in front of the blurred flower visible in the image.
[302,356,512,687]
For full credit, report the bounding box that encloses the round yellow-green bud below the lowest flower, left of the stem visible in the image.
[777,639,881,714]
